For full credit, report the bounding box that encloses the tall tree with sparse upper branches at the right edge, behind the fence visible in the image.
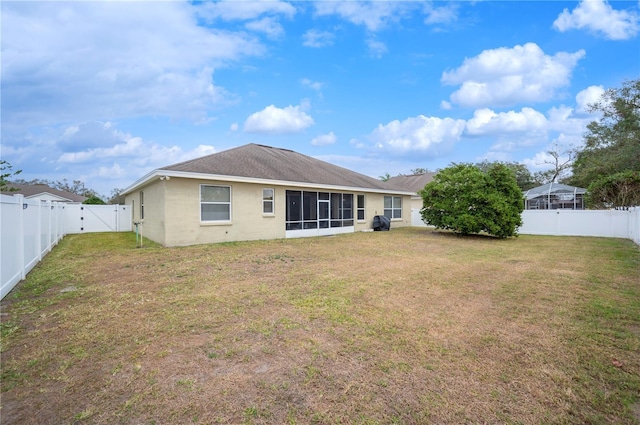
[570,79,640,187]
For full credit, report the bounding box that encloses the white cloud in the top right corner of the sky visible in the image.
[553,0,640,40]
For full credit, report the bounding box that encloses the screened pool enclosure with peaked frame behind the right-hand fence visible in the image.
[523,183,587,210]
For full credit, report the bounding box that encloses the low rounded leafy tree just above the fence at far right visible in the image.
[587,171,640,209]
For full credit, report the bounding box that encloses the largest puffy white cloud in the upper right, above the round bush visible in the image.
[442,43,585,107]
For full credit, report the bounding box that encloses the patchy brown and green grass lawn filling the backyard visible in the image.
[0,228,640,425]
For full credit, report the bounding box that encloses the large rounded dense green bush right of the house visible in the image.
[420,163,524,238]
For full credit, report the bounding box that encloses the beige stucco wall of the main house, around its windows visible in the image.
[126,177,411,246]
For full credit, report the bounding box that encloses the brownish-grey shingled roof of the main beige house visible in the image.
[158,143,406,191]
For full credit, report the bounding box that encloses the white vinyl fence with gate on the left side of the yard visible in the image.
[0,195,132,299]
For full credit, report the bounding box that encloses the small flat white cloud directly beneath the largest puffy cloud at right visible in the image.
[466,108,548,136]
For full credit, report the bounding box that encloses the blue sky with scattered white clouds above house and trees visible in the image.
[0,0,640,196]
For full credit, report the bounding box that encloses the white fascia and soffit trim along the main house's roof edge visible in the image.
[122,170,415,196]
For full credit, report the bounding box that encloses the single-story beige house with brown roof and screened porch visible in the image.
[123,144,413,246]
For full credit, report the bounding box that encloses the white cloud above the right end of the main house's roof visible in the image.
[370,115,465,156]
